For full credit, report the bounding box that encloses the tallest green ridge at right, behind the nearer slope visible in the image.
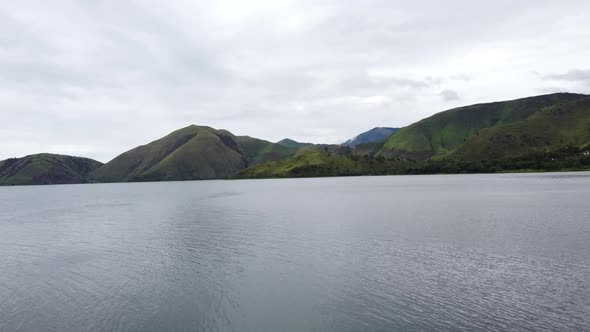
[378,93,587,159]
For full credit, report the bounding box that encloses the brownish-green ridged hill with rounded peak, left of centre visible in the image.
[91,125,296,182]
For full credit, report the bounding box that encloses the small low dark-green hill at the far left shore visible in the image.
[0,153,102,185]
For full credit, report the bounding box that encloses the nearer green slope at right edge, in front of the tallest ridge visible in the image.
[448,98,590,160]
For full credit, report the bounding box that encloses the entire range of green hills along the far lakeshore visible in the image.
[0,93,590,185]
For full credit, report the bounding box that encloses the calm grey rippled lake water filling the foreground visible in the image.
[0,173,590,331]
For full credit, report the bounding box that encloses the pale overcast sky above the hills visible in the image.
[0,0,590,162]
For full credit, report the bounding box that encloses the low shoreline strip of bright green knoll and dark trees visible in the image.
[234,146,590,178]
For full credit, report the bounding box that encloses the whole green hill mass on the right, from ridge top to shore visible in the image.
[237,94,590,178]
